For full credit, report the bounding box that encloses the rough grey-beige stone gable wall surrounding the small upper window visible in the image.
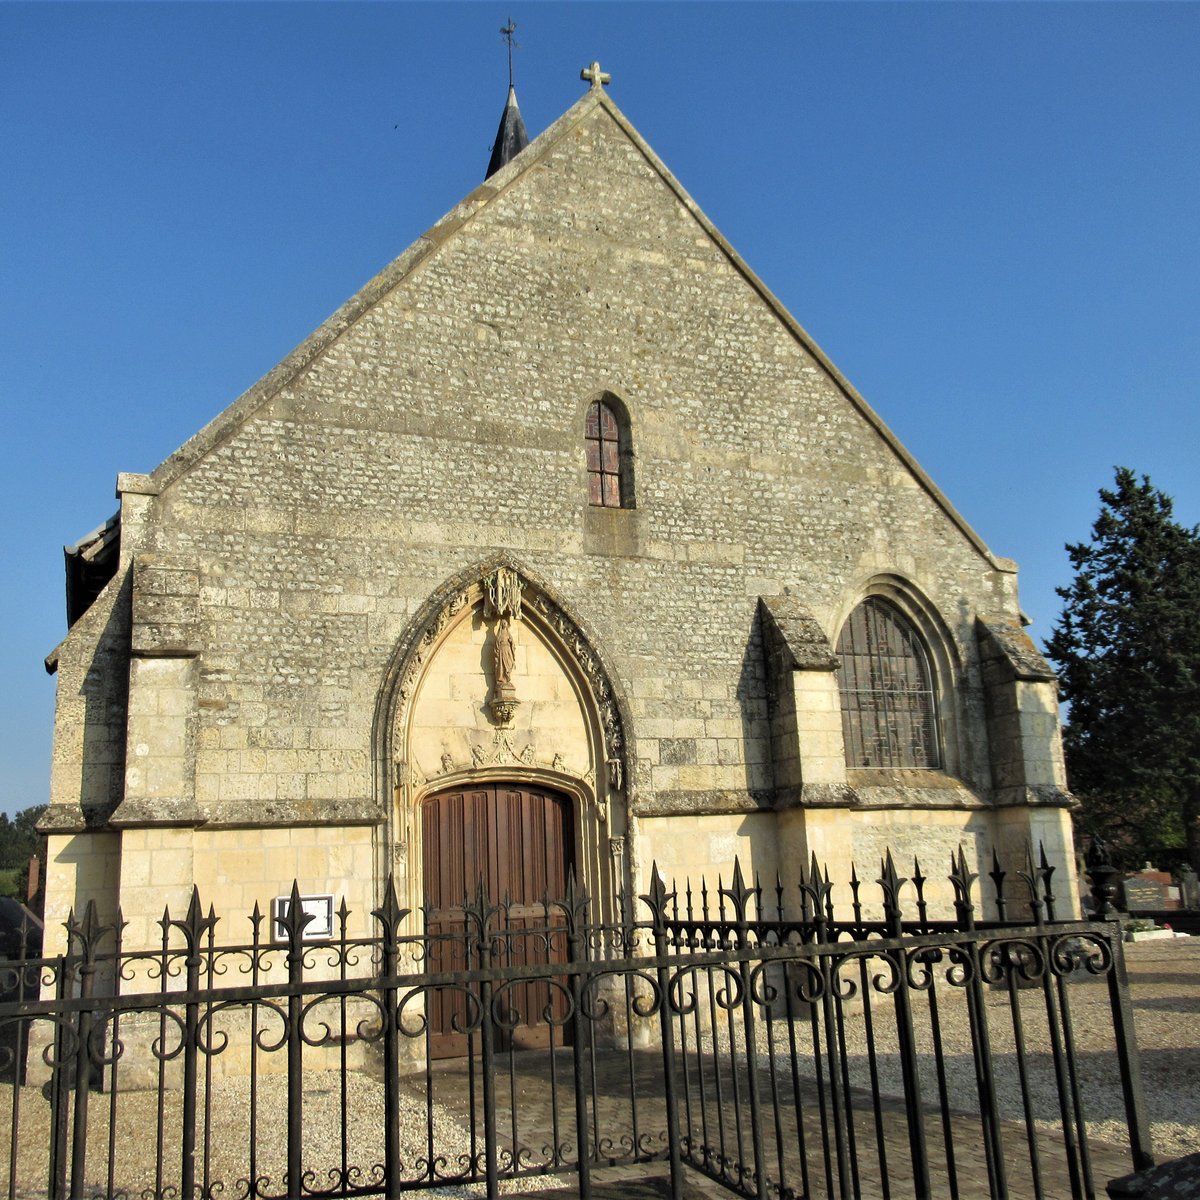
[108,98,1015,840]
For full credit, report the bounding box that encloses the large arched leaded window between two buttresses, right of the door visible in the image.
[838,596,942,769]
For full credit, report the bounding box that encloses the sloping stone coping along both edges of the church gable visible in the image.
[149,88,1015,571]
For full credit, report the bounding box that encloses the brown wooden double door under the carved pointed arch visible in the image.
[421,782,575,1057]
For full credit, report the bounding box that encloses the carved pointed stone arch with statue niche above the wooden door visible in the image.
[373,554,632,908]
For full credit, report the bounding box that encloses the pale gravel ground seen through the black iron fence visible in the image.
[0,938,1200,1196]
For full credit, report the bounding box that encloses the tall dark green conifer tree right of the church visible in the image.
[1046,468,1200,870]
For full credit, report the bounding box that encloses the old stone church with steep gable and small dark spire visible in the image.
[41,64,1078,953]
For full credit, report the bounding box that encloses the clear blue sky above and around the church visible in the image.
[0,2,1200,811]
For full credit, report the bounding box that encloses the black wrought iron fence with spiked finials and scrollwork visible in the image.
[0,851,1152,1200]
